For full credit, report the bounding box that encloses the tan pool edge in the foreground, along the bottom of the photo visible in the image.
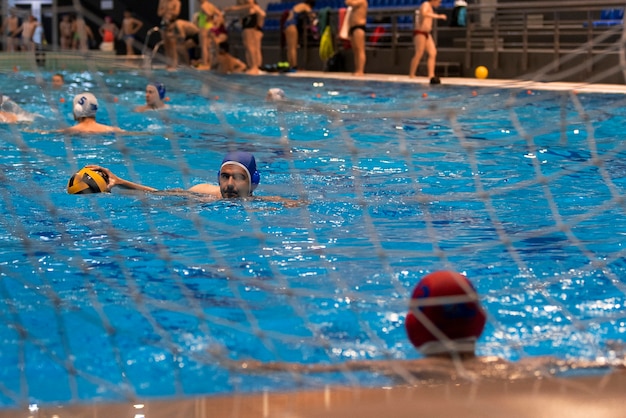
[0,372,626,418]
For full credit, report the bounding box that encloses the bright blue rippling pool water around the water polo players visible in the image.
[0,72,626,407]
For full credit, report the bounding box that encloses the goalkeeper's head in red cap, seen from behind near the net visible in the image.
[405,271,486,356]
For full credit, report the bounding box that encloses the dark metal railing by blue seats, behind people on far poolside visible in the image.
[256,0,626,76]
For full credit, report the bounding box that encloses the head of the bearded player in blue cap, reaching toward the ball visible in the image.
[217,151,261,198]
